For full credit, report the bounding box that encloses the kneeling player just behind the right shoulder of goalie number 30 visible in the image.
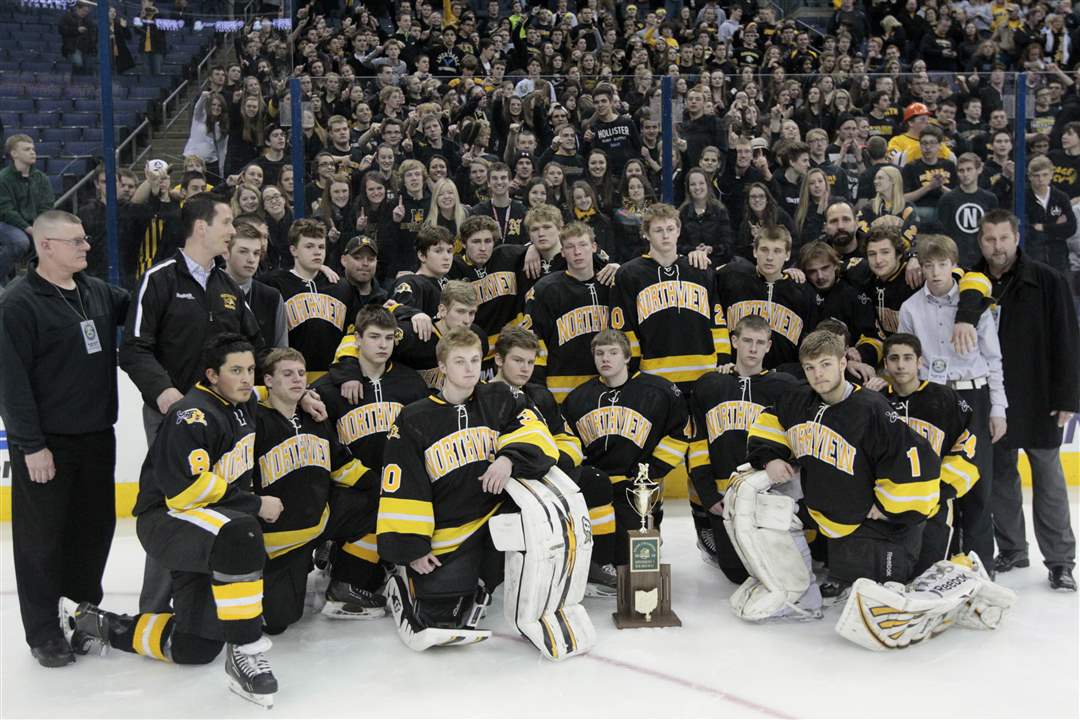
[495,325,616,597]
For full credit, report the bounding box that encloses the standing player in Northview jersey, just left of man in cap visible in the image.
[266,218,352,380]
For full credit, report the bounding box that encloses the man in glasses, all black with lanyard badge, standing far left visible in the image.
[0,210,129,667]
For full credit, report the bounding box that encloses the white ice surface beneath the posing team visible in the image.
[0,498,1080,718]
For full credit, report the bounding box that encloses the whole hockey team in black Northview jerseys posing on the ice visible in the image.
[23,196,1045,705]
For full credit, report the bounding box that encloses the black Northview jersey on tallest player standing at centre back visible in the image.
[611,255,731,383]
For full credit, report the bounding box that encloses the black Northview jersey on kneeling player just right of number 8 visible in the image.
[252,403,366,559]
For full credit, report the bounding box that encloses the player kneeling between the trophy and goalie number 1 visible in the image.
[687,314,796,584]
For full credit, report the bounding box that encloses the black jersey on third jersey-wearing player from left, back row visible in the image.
[447,245,527,349]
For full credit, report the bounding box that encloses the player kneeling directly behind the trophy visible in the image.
[563,328,688,565]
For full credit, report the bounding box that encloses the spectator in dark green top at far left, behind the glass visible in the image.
[0,135,55,287]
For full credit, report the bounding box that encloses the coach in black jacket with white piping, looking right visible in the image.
[120,193,262,612]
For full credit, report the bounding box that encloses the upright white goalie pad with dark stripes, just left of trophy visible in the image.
[488,467,596,661]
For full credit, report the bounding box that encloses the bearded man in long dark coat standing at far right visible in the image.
[975,209,1080,592]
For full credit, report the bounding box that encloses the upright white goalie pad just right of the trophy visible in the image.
[724,471,821,621]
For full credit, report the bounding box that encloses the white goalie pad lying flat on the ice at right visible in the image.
[836,553,1016,650]
